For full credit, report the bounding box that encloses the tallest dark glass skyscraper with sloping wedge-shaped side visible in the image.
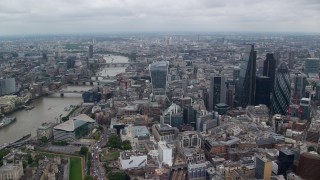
[236,45,257,107]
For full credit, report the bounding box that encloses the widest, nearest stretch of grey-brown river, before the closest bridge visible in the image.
[0,93,82,144]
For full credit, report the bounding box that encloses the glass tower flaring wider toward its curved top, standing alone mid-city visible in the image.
[149,61,169,96]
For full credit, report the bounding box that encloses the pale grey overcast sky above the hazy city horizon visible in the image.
[0,0,320,35]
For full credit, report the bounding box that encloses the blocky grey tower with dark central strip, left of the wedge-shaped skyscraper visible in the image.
[209,76,226,111]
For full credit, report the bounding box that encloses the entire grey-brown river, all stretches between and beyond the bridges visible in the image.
[0,55,128,145]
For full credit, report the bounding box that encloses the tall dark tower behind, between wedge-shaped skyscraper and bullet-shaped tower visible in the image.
[263,53,276,89]
